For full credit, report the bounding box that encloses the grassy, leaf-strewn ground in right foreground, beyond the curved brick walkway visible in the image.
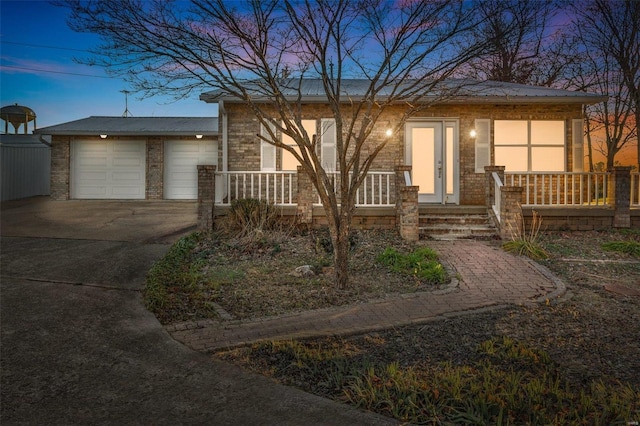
[216,231,640,424]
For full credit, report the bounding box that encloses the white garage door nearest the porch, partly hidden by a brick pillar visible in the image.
[164,141,218,200]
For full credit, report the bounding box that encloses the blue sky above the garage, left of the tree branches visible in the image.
[0,0,217,131]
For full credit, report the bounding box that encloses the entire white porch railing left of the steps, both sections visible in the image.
[216,171,396,207]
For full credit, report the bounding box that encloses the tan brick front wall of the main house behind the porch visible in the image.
[225,104,582,205]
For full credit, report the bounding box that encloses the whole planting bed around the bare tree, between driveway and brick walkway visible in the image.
[144,227,450,324]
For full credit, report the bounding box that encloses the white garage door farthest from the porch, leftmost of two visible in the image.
[71,140,146,199]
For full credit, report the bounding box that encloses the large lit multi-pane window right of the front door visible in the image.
[493,120,565,172]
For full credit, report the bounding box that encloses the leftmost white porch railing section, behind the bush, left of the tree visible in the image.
[216,171,298,206]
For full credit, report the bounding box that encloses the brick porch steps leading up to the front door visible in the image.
[419,206,498,240]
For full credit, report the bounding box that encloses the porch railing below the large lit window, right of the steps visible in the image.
[504,172,608,206]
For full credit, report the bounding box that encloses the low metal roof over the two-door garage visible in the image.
[34,116,218,136]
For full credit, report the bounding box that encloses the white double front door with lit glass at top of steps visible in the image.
[405,120,459,204]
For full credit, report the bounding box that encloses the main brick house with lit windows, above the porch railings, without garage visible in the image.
[201,80,606,205]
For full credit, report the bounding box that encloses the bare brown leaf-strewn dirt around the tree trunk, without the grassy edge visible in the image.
[196,230,449,319]
